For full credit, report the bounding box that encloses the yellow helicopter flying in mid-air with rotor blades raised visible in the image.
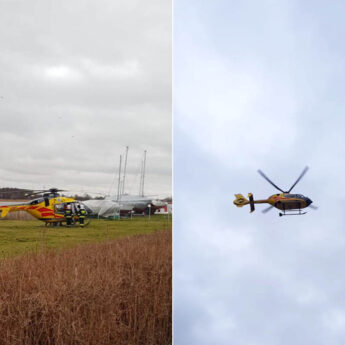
[234,167,317,217]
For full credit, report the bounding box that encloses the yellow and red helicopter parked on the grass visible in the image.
[0,188,89,226]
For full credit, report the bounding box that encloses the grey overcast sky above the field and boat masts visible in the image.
[0,0,172,194]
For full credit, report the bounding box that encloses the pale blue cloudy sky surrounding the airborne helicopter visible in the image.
[173,0,345,345]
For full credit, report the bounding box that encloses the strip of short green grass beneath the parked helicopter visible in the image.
[0,215,171,258]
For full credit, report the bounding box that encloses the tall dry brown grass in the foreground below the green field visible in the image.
[0,227,172,345]
